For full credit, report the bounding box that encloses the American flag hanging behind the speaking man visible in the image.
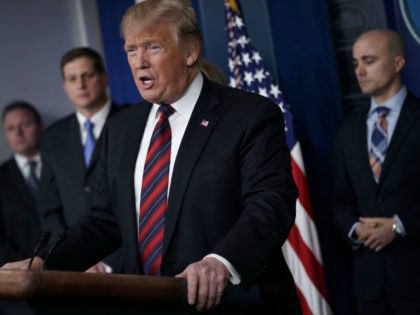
[225,0,332,315]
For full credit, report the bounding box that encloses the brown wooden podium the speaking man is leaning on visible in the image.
[0,270,260,315]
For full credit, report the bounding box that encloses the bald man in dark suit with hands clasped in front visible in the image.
[332,29,420,315]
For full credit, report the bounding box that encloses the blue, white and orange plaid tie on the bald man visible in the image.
[369,106,389,182]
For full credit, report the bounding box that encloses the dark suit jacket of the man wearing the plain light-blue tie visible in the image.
[38,104,127,272]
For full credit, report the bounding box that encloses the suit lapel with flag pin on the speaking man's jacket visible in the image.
[163,80,220,255]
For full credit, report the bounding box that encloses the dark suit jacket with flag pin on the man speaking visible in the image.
[44,79,300,314]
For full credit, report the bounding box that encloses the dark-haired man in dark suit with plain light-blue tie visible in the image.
[38,47,127,272]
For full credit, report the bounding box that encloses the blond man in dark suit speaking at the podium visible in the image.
[3,0,301,314]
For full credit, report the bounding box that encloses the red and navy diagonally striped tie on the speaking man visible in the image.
[139,105,175,275]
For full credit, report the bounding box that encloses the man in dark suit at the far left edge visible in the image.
[0,101,43,264]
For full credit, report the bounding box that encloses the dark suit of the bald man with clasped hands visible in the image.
[332,93,420,299]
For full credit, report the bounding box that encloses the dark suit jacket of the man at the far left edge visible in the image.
[0,158,41,265]
